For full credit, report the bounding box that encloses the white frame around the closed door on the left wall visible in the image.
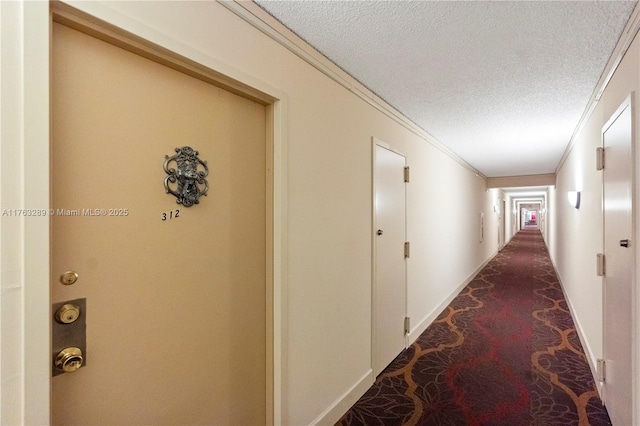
[371,137,409,374]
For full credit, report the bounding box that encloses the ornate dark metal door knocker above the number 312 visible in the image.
[164,146,209,207]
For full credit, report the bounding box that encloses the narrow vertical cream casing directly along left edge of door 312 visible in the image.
[23,1,51,424]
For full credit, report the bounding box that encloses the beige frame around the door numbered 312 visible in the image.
[10,1,288,424]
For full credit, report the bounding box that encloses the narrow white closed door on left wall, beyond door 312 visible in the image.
[373,144,406,375]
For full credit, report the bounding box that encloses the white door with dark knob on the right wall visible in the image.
[602,95,635,425]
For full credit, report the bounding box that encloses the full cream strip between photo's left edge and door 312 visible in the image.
[0,1,50,424]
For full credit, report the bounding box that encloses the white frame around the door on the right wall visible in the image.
[596,92,640,424]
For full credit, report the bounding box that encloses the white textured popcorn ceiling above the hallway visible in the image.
[256,0,636,177]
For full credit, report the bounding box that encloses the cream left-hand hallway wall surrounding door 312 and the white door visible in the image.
[2,1,498,425]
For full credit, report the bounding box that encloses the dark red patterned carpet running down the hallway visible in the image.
[338,230,611,426]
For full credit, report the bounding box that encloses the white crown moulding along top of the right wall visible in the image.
[555,3,640,175]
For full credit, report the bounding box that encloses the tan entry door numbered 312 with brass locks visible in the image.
[51,23,267,425]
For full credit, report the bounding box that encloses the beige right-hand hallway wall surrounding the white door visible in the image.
[549,30,640,421]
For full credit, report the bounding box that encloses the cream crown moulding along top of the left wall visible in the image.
[220,0,486,179]
